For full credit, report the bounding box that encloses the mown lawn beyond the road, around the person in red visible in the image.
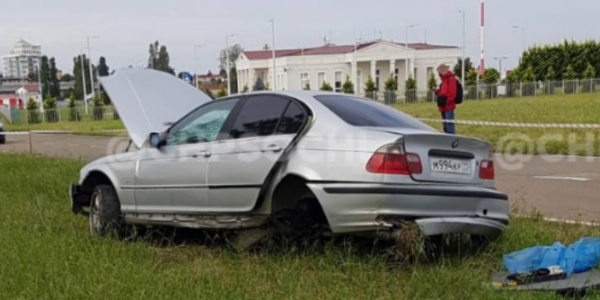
[397,94,600,156]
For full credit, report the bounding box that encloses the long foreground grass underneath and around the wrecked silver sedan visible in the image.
[0,154,600,300]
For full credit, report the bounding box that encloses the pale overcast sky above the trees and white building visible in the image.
[0,0,600,73]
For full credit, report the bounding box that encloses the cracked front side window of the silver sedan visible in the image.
[166,99,238,146]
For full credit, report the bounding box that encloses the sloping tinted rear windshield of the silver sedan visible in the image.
[315,95,433,131]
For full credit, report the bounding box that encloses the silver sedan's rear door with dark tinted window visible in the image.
[208,95,307,212]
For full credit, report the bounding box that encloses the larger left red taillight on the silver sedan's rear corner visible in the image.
[367,144,423,175]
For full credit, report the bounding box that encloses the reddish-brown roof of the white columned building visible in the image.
[244,42,457,60]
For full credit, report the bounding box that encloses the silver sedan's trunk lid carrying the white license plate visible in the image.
[360,128,493,185]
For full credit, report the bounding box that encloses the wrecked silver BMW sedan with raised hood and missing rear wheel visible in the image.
[71,69,509,246]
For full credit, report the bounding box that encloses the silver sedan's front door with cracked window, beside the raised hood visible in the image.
[134,99,238,213]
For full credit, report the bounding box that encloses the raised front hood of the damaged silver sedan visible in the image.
[100,68,211,148]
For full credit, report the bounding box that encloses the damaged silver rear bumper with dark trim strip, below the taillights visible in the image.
[309,183,509,237]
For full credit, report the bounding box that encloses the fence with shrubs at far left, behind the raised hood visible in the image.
[4,106,119,125]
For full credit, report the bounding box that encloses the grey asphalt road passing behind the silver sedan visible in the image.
[0,135,600,222]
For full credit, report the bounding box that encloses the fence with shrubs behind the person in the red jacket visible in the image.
[364,79,600,105]
